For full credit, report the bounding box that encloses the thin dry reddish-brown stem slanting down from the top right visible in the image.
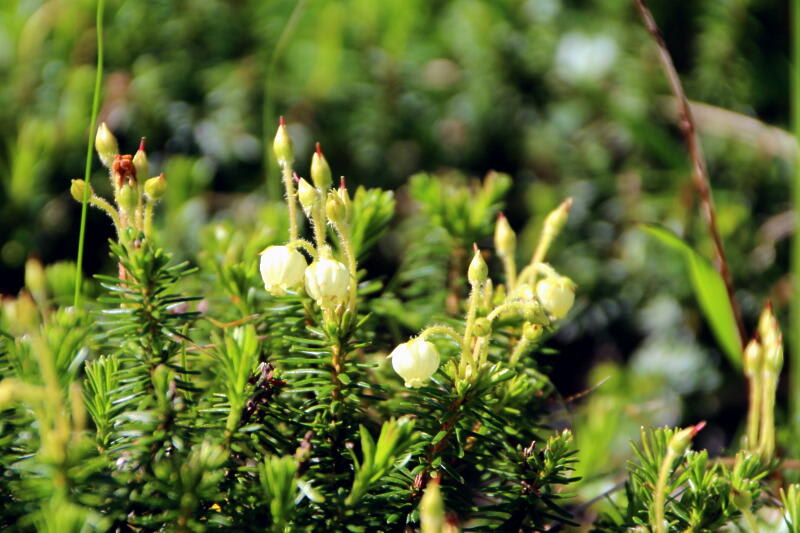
[634,0,746,347]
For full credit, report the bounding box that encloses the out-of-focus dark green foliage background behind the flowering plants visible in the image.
[0,0,795,516]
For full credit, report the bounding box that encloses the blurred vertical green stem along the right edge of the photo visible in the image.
[789,0,800,444]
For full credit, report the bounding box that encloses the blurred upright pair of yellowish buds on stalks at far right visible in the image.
[743,302,783,461]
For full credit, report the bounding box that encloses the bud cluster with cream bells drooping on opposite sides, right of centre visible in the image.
[389,200,575,388]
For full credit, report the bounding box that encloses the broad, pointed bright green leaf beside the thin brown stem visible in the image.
[641,224,742,368]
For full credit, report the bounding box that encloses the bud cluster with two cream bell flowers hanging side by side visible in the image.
[260,117,356,323]
